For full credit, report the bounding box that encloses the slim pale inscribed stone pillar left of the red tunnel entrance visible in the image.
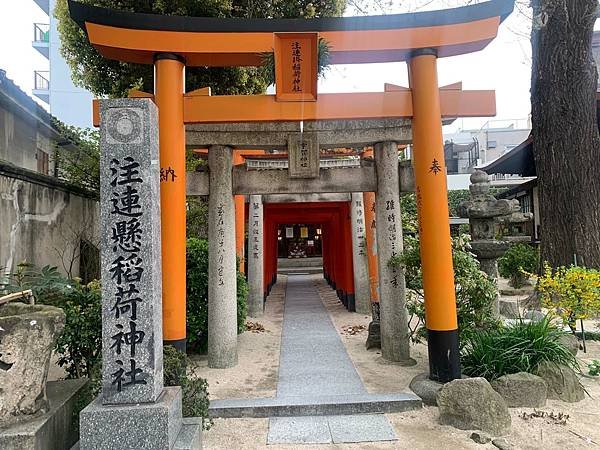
[248,195,265,317]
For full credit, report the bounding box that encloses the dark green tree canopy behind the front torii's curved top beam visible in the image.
[54,0,346,97]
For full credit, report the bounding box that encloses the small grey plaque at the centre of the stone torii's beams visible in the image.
[288,133,320,178]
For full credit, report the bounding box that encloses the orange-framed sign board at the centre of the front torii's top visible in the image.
[273,33,319,102]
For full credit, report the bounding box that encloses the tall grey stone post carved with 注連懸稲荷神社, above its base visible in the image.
[100,99,163,404]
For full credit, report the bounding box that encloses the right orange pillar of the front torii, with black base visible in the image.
[409,49,460,382]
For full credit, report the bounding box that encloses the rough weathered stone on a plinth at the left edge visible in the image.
[0,303,65,427]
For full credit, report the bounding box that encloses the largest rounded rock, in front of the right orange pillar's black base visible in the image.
[437,378,511,436]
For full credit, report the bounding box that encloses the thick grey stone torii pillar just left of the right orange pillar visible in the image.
[375,142,415,365]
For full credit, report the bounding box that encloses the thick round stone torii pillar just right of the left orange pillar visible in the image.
[208,145,237,369]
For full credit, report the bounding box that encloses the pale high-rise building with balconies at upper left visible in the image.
[32,0,92,127]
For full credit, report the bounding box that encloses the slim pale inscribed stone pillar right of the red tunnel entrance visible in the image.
[350,192,371,314]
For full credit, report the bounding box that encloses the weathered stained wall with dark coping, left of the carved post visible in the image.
[0,163,99,278]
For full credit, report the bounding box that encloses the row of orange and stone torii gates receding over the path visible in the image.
[69,0,514,381]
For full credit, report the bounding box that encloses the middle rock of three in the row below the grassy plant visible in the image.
[491,372,548,408]
